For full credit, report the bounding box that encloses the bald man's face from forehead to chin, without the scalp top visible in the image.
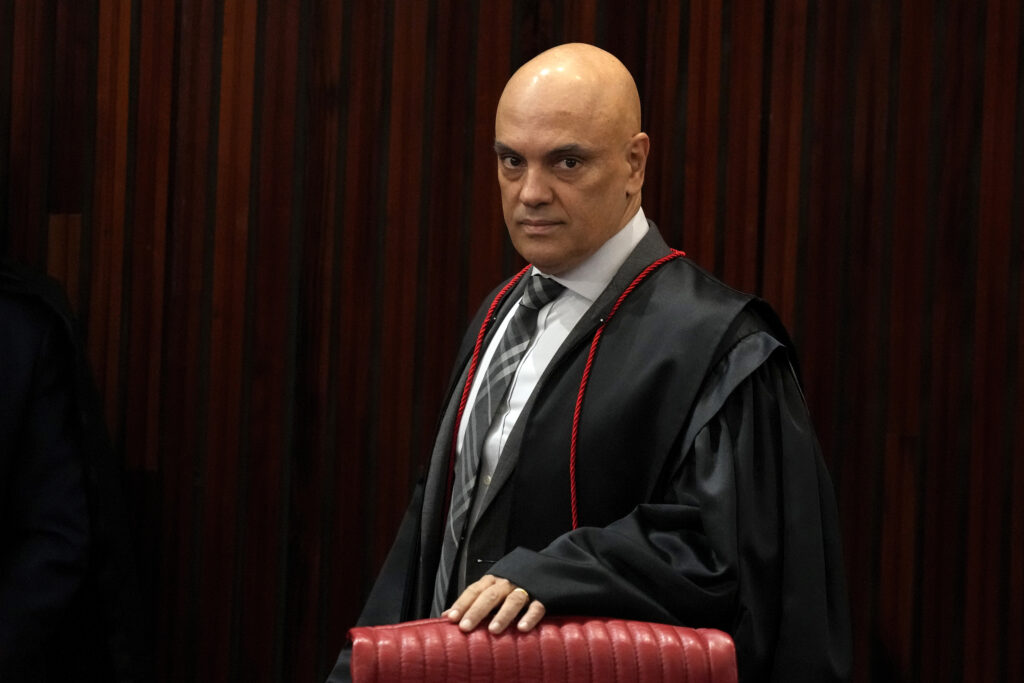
[495,102,647,274]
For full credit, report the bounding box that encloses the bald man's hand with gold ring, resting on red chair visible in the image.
[441,574,545,634]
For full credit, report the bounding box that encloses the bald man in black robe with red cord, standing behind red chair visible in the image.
[327,44,850,681]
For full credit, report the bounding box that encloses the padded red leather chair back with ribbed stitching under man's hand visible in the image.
[348,617,736,683]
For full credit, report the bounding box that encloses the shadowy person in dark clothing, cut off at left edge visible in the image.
[0,259,152,683]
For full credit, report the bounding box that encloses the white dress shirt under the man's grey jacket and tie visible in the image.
[458,209,647,497]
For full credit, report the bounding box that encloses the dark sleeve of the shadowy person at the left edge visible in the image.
[0,309,89,669]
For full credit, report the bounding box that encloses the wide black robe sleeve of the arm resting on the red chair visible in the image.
[492,332,851,681]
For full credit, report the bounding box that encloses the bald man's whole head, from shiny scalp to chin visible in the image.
[495,43,650,274]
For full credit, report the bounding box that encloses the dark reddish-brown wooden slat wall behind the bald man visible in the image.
[0,0,1024,681]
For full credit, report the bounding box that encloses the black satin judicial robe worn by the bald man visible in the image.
[339,224,851,681]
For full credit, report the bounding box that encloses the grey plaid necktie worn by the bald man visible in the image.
[431,275,565,615]
